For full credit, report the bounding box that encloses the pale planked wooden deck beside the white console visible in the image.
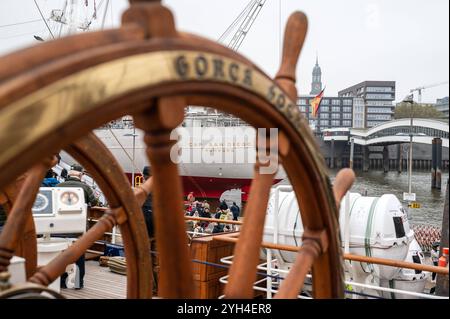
[61,260,127,299]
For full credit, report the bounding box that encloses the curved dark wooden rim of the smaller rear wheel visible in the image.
[66,133,152,298]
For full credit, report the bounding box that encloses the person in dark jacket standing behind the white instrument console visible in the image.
[56,164,98,288]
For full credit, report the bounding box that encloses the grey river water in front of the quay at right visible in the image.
[330,170,449,227]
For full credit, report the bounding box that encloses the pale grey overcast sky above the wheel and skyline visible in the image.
[0,0,449,102]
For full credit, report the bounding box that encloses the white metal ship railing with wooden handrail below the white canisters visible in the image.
[214,233,449,299]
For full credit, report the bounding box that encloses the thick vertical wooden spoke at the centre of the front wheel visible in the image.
[135,98,194,298]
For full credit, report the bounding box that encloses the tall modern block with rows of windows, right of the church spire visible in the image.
[338,81,395,128]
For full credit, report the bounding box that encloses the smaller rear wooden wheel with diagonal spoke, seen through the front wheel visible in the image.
[0,134,152,298]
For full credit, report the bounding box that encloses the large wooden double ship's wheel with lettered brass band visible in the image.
[0,1,353,298]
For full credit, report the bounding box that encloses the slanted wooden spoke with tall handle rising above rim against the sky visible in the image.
[225,12,306,298]
